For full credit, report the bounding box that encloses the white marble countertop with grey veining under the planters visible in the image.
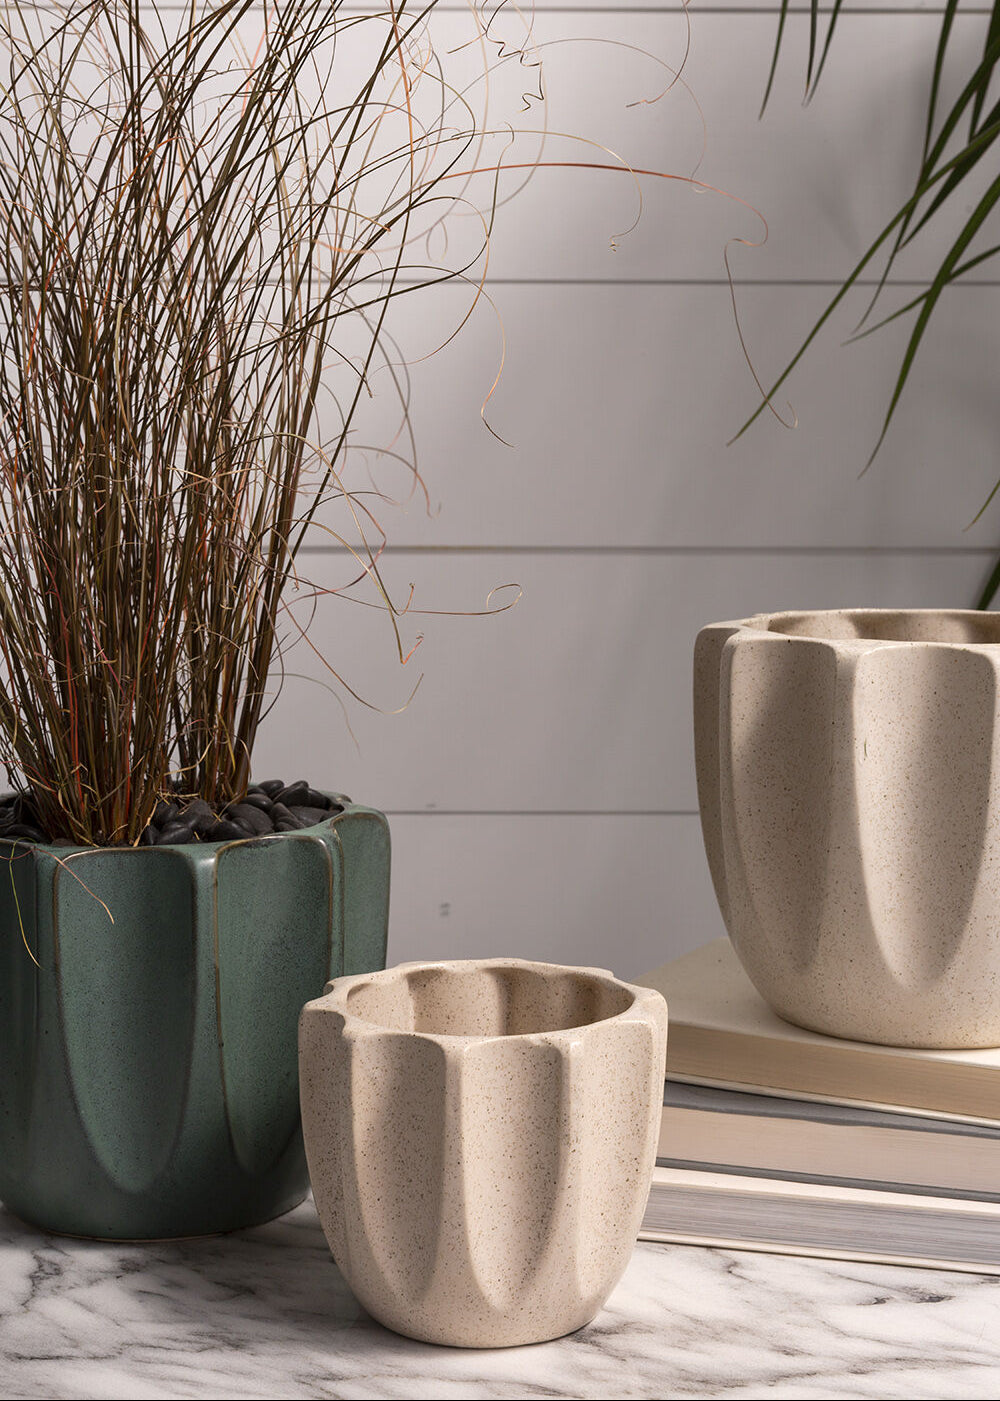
[0,1202,1000,1398]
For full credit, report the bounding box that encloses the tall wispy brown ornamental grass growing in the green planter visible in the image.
[0,0,529,845]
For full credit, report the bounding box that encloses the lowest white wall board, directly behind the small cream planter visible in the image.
[388,817,724,978]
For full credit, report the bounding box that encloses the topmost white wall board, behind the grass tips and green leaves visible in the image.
[7,8,996,280]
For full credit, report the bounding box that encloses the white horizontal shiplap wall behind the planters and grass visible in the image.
[250,0,1000,975]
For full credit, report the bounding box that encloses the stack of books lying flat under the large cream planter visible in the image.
[639,939,1000,1274]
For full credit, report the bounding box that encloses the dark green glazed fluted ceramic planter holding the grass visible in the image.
[0,799,389,1240]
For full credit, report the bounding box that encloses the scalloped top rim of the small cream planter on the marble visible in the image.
[313,958,661,1047]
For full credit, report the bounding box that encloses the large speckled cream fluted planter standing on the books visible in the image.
[695,608,1000,1048]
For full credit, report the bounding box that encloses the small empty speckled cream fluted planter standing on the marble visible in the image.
[300,958,667,1348]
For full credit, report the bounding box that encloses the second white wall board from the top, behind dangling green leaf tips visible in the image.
[312,278,1000,548]
